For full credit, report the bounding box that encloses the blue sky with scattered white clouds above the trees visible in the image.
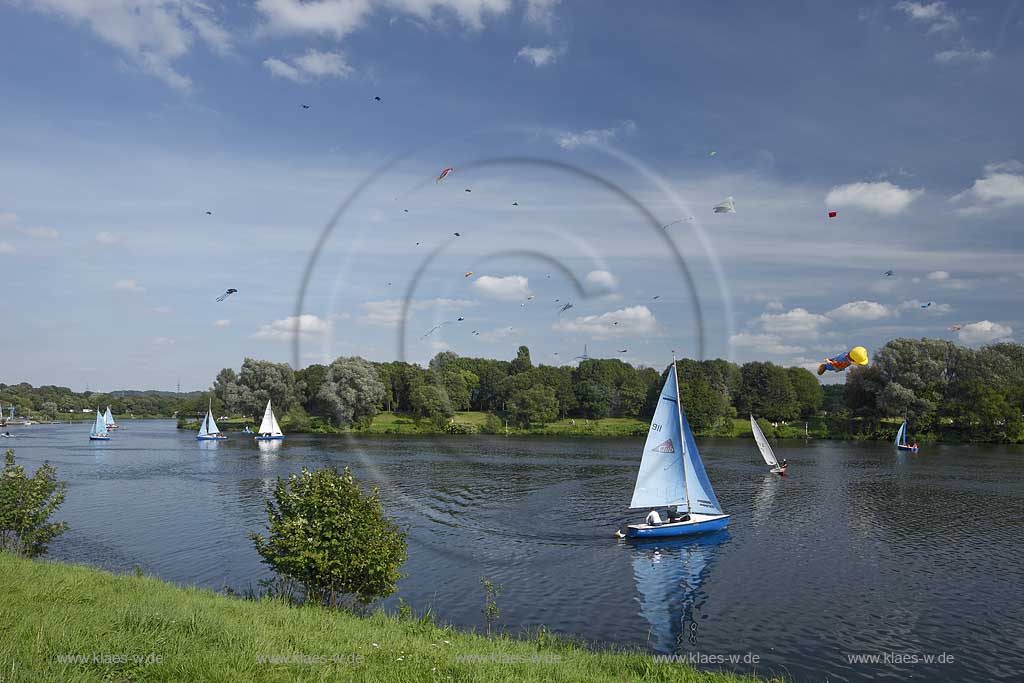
[0,0,1024,391]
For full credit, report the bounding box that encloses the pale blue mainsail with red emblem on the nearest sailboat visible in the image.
[630,364,686,508]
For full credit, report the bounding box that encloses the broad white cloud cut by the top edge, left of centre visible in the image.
[256,0,512,40]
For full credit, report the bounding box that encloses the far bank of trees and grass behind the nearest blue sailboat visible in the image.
[197,339,1024,442]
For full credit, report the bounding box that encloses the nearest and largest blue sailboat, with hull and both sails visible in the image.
[626,358,729,539]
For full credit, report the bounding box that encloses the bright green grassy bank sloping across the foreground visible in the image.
[0,553,750,683]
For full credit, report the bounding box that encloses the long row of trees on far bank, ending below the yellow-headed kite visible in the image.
[213,346,823,431]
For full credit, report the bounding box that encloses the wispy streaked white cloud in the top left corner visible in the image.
[15,0,231,90]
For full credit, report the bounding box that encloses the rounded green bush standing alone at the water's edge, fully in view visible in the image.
[249,468,407,607]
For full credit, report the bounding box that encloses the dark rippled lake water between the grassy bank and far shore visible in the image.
[0,421,1024,681]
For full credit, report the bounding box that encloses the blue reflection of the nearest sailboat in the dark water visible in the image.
[633,529,729,652]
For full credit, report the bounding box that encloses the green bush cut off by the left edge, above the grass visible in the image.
[0,449,68,557]
